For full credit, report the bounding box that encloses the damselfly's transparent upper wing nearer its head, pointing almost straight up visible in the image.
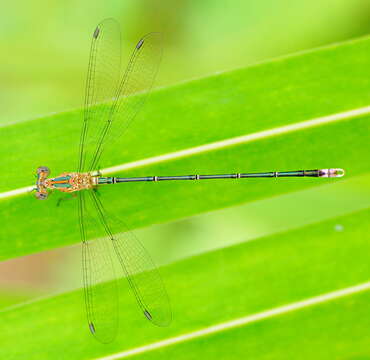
[77,19,121,172]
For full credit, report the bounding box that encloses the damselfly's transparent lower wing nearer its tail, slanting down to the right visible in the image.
[90,192,172,326]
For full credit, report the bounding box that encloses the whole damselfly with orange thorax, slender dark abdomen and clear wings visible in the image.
[36,19,344,343]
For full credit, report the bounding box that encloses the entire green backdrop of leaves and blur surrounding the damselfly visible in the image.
[0,0,370,360]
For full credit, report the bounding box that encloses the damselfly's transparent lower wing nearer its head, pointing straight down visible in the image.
[79,191,118,343]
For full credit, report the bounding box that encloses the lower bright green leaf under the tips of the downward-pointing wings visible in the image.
[0,210,370,360]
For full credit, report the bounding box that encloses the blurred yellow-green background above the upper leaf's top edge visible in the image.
[0,0,370,124]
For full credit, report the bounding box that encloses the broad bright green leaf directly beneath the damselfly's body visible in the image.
[0,39,370,260]
